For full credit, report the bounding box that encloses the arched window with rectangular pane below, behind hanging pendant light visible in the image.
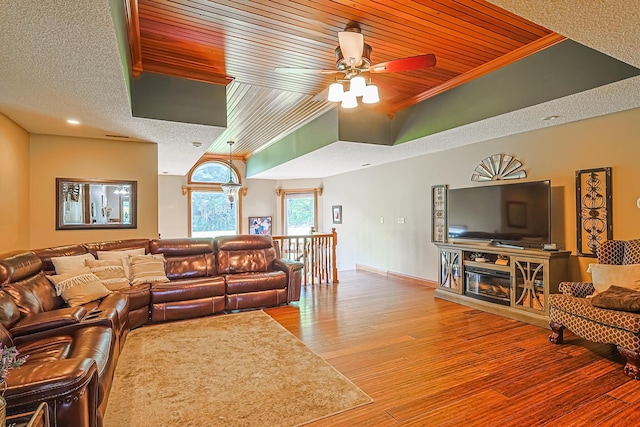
[188,160,240,237]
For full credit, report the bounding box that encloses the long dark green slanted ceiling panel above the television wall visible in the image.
[394,40,640,144]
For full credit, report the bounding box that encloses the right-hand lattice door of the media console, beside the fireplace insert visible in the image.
[511,257,548,314]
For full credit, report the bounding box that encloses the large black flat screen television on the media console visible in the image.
[447,181,551,248]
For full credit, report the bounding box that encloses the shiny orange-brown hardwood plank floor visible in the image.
[265,271,640,427]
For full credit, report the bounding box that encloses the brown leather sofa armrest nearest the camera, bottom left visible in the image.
[4,358,98,426]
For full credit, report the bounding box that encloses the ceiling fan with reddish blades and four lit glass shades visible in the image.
[274,23,436,108]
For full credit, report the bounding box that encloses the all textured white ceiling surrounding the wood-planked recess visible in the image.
[0,0,640,179]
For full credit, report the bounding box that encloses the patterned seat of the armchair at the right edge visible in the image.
[549,294,640,334]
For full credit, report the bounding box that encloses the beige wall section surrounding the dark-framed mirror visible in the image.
[29,135,158,248]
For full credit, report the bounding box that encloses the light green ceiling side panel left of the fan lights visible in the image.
[247,108,338,178]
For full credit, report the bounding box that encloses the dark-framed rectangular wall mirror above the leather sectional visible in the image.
[56,178,138,230]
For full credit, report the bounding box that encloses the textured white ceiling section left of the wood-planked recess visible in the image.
[0,0,224,175]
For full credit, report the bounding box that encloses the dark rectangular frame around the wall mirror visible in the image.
[56,178,138,230]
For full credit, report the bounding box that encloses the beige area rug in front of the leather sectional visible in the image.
[104,311,372,427]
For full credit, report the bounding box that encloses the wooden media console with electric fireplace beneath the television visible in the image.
[435,243,571,328]
